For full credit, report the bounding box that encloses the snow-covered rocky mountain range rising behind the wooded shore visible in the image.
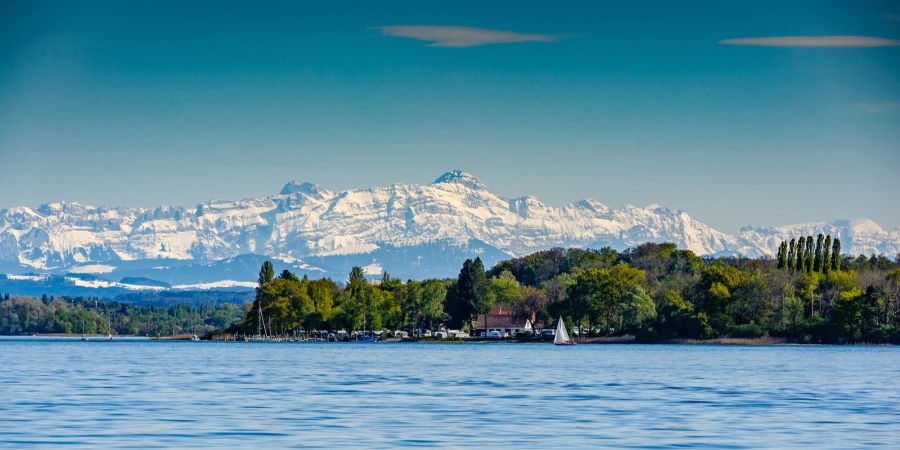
[0,170,900,284]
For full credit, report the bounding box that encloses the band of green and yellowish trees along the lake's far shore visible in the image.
[0,241,900,344]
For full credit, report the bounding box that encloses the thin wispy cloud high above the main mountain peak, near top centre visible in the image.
[376,25,562,47]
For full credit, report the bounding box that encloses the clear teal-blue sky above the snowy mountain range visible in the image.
[0,1,900,232]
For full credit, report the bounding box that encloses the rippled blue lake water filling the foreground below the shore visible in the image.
[0,338,900,449]
